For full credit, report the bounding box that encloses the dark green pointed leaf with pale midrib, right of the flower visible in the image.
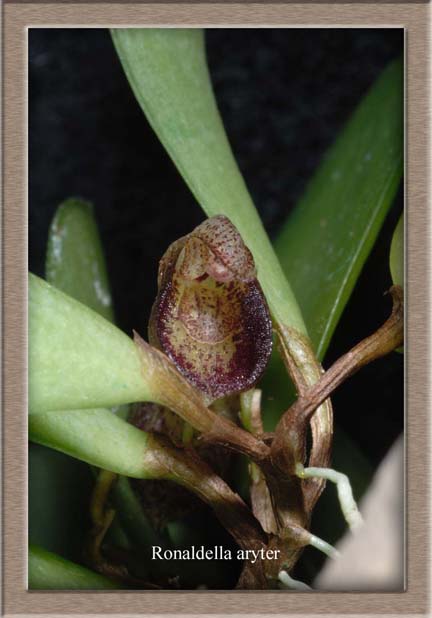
[275,60,403,359]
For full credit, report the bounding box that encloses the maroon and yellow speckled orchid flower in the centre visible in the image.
[149,215,272,399]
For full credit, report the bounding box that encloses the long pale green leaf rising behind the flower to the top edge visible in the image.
[112,28,305,333]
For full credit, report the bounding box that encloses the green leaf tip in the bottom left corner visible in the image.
[28,545,121,590]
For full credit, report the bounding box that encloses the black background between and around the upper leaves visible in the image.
[29,29,403,584]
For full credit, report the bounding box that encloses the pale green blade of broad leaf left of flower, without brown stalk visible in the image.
[29,275,155,413]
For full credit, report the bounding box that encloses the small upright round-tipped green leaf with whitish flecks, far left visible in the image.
[46,199,113,322]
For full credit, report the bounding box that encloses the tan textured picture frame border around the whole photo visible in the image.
[3,2,431,616]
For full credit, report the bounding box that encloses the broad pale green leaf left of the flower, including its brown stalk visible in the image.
[29,275,243,431]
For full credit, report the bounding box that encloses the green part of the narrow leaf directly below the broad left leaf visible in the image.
[29,409,154,479]
